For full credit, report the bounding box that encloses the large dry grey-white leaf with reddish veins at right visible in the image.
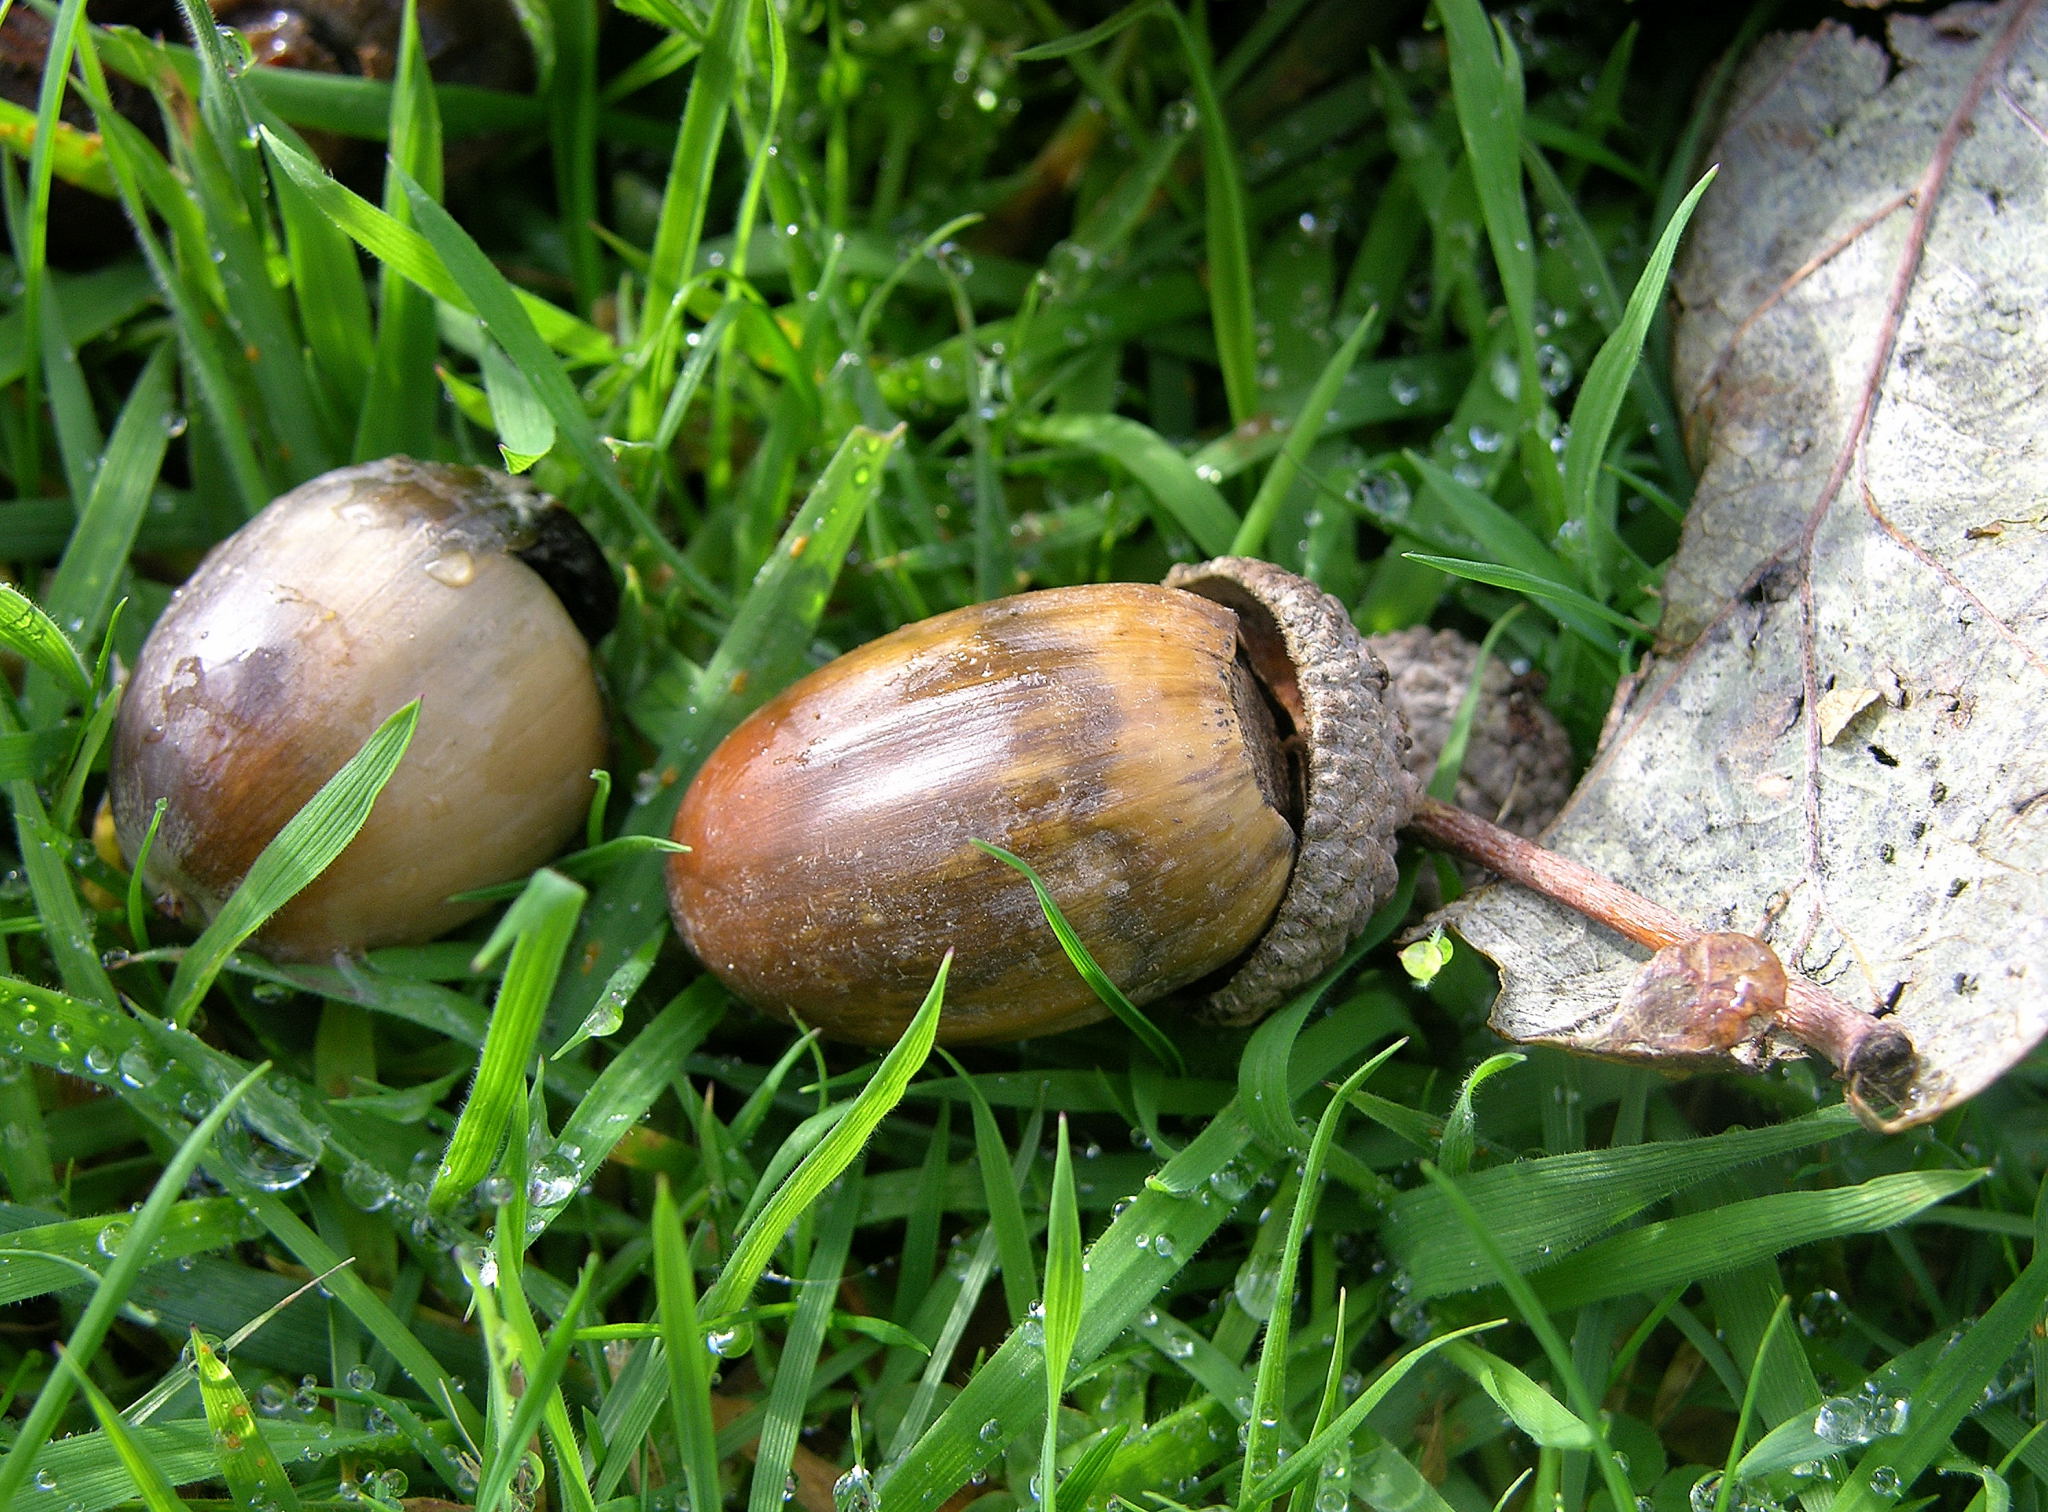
[1448,0,2048,1127]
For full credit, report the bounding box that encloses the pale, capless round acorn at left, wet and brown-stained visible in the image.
[109,457,616,959]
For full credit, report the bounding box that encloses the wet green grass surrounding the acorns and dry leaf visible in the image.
[0,0,2048,1512]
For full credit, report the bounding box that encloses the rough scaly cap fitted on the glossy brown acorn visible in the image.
[1165,557,1419,1024]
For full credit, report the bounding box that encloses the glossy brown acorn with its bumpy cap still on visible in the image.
[668,557,1415,1045]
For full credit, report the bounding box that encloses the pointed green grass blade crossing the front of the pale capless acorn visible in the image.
[164,701,420,1024]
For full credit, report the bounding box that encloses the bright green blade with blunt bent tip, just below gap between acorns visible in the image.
[426,867,588,1213]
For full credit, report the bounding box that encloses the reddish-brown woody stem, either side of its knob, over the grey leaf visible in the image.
[1407,797,1913,1100]
